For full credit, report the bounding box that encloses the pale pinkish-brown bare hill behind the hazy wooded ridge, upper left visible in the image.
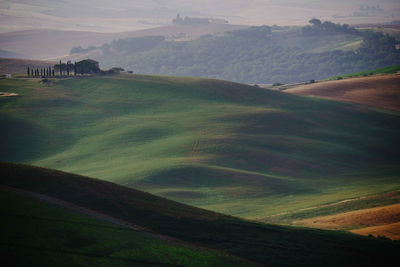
[0,24,246,59]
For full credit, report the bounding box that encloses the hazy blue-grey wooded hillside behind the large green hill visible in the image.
[94,20,400,84]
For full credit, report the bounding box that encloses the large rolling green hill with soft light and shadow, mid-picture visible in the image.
[0,75,400,218]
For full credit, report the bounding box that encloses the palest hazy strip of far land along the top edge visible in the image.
[0,0,400,32]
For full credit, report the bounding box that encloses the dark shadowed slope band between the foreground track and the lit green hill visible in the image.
[0,163,398,266]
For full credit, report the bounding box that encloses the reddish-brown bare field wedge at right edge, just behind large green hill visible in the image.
[285,74,400,111]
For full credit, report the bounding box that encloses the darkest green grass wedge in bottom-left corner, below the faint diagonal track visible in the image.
[0,187,244,266]
